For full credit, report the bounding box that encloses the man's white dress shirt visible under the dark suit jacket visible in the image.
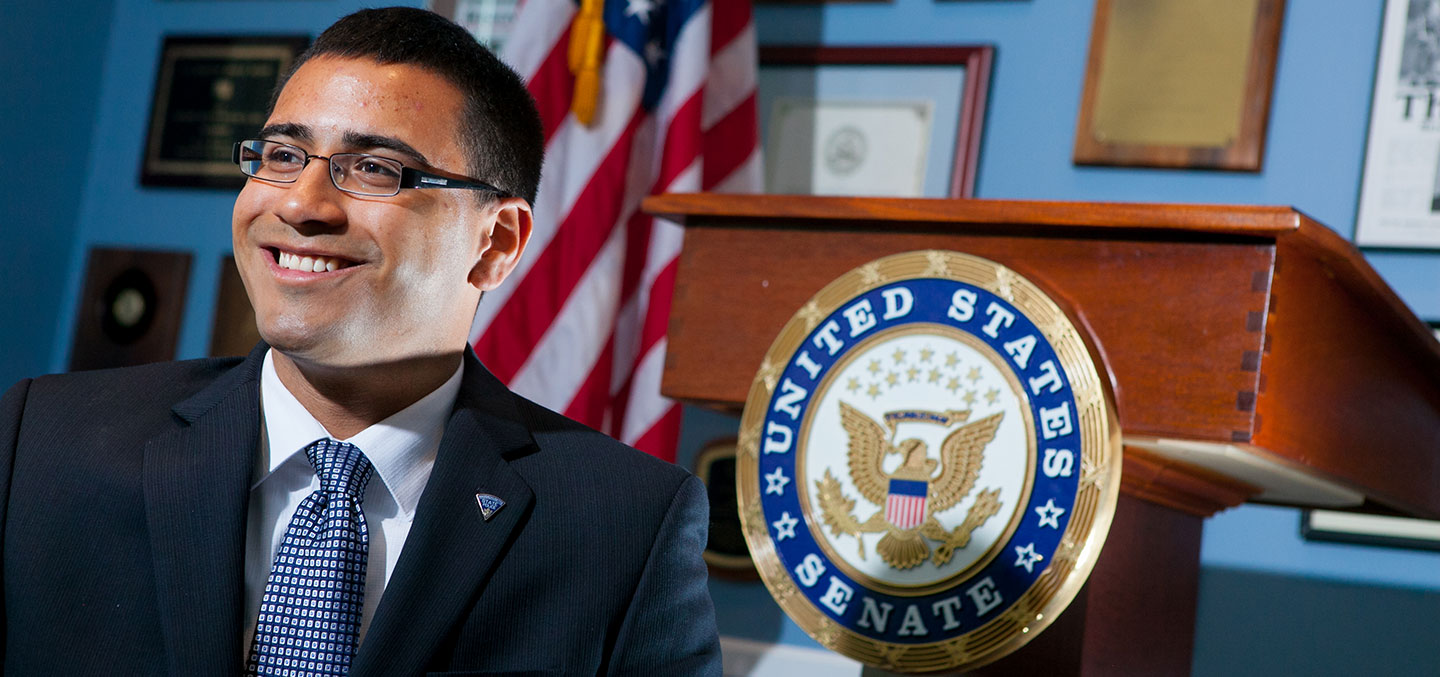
[245,353,465,653]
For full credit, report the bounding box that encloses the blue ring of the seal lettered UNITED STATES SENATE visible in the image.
[759,278,1083,644]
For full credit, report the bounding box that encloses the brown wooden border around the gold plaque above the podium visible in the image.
[1074,0,1284,171]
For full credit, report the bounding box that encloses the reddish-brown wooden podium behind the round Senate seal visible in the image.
[644,194,1440,674]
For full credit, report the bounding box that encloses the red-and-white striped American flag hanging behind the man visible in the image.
[471,0,762,461]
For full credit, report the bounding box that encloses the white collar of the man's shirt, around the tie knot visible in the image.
[252,350,465,517]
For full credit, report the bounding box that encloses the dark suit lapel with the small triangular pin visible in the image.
[350,350,534,676]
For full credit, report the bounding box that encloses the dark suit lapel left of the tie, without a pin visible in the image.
[144,344,266,674]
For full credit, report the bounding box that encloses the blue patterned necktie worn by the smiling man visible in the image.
[245,438,373,676]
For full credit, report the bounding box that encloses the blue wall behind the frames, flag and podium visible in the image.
[0,0,1440,674]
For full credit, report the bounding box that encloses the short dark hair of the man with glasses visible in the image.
[271,7,544,205]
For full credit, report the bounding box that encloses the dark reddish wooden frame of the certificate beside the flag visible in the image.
[760,45,995,197]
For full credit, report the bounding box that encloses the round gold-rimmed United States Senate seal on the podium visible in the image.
[737,251,1120,673]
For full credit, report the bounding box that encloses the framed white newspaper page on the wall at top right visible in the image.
[1355,0,1440,249]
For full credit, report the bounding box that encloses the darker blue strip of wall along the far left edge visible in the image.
[0,0,116,387]
